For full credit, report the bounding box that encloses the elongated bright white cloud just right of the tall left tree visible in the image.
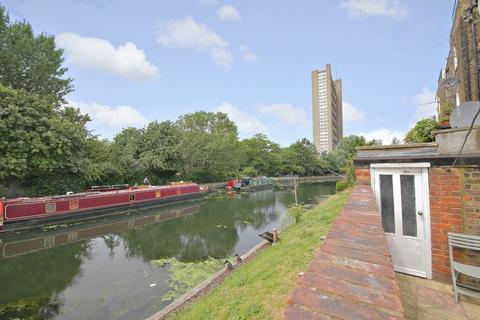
[55,32,159,81]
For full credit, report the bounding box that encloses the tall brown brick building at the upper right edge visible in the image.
[437,0,480,122]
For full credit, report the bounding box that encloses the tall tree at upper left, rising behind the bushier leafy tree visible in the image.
[0,5,73,104]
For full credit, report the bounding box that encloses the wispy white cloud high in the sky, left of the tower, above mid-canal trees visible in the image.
[157,17,233,68]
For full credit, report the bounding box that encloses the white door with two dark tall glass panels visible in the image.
[372,165,431,278]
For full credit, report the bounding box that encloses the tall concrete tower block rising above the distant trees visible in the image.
[312,64,343,153]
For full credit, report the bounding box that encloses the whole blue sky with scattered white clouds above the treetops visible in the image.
[0,0,454,146]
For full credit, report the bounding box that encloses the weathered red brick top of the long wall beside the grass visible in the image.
[285,185,404,320]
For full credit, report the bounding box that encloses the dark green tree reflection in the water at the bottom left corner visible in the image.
[0,241,90,319]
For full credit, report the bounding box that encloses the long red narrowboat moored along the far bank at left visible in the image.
[0,182,208,232]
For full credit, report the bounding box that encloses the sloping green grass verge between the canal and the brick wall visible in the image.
[174,189,351,320]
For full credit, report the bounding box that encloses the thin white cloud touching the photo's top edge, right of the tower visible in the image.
[340,0,408,19]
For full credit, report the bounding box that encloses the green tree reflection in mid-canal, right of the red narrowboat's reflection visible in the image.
[120,190,284,261]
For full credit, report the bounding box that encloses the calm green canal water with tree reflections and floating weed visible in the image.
[0,182,335,320]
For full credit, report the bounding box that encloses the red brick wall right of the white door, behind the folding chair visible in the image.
[429,168,480,281]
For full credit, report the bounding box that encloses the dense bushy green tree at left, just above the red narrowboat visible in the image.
[0,86,90,191]
